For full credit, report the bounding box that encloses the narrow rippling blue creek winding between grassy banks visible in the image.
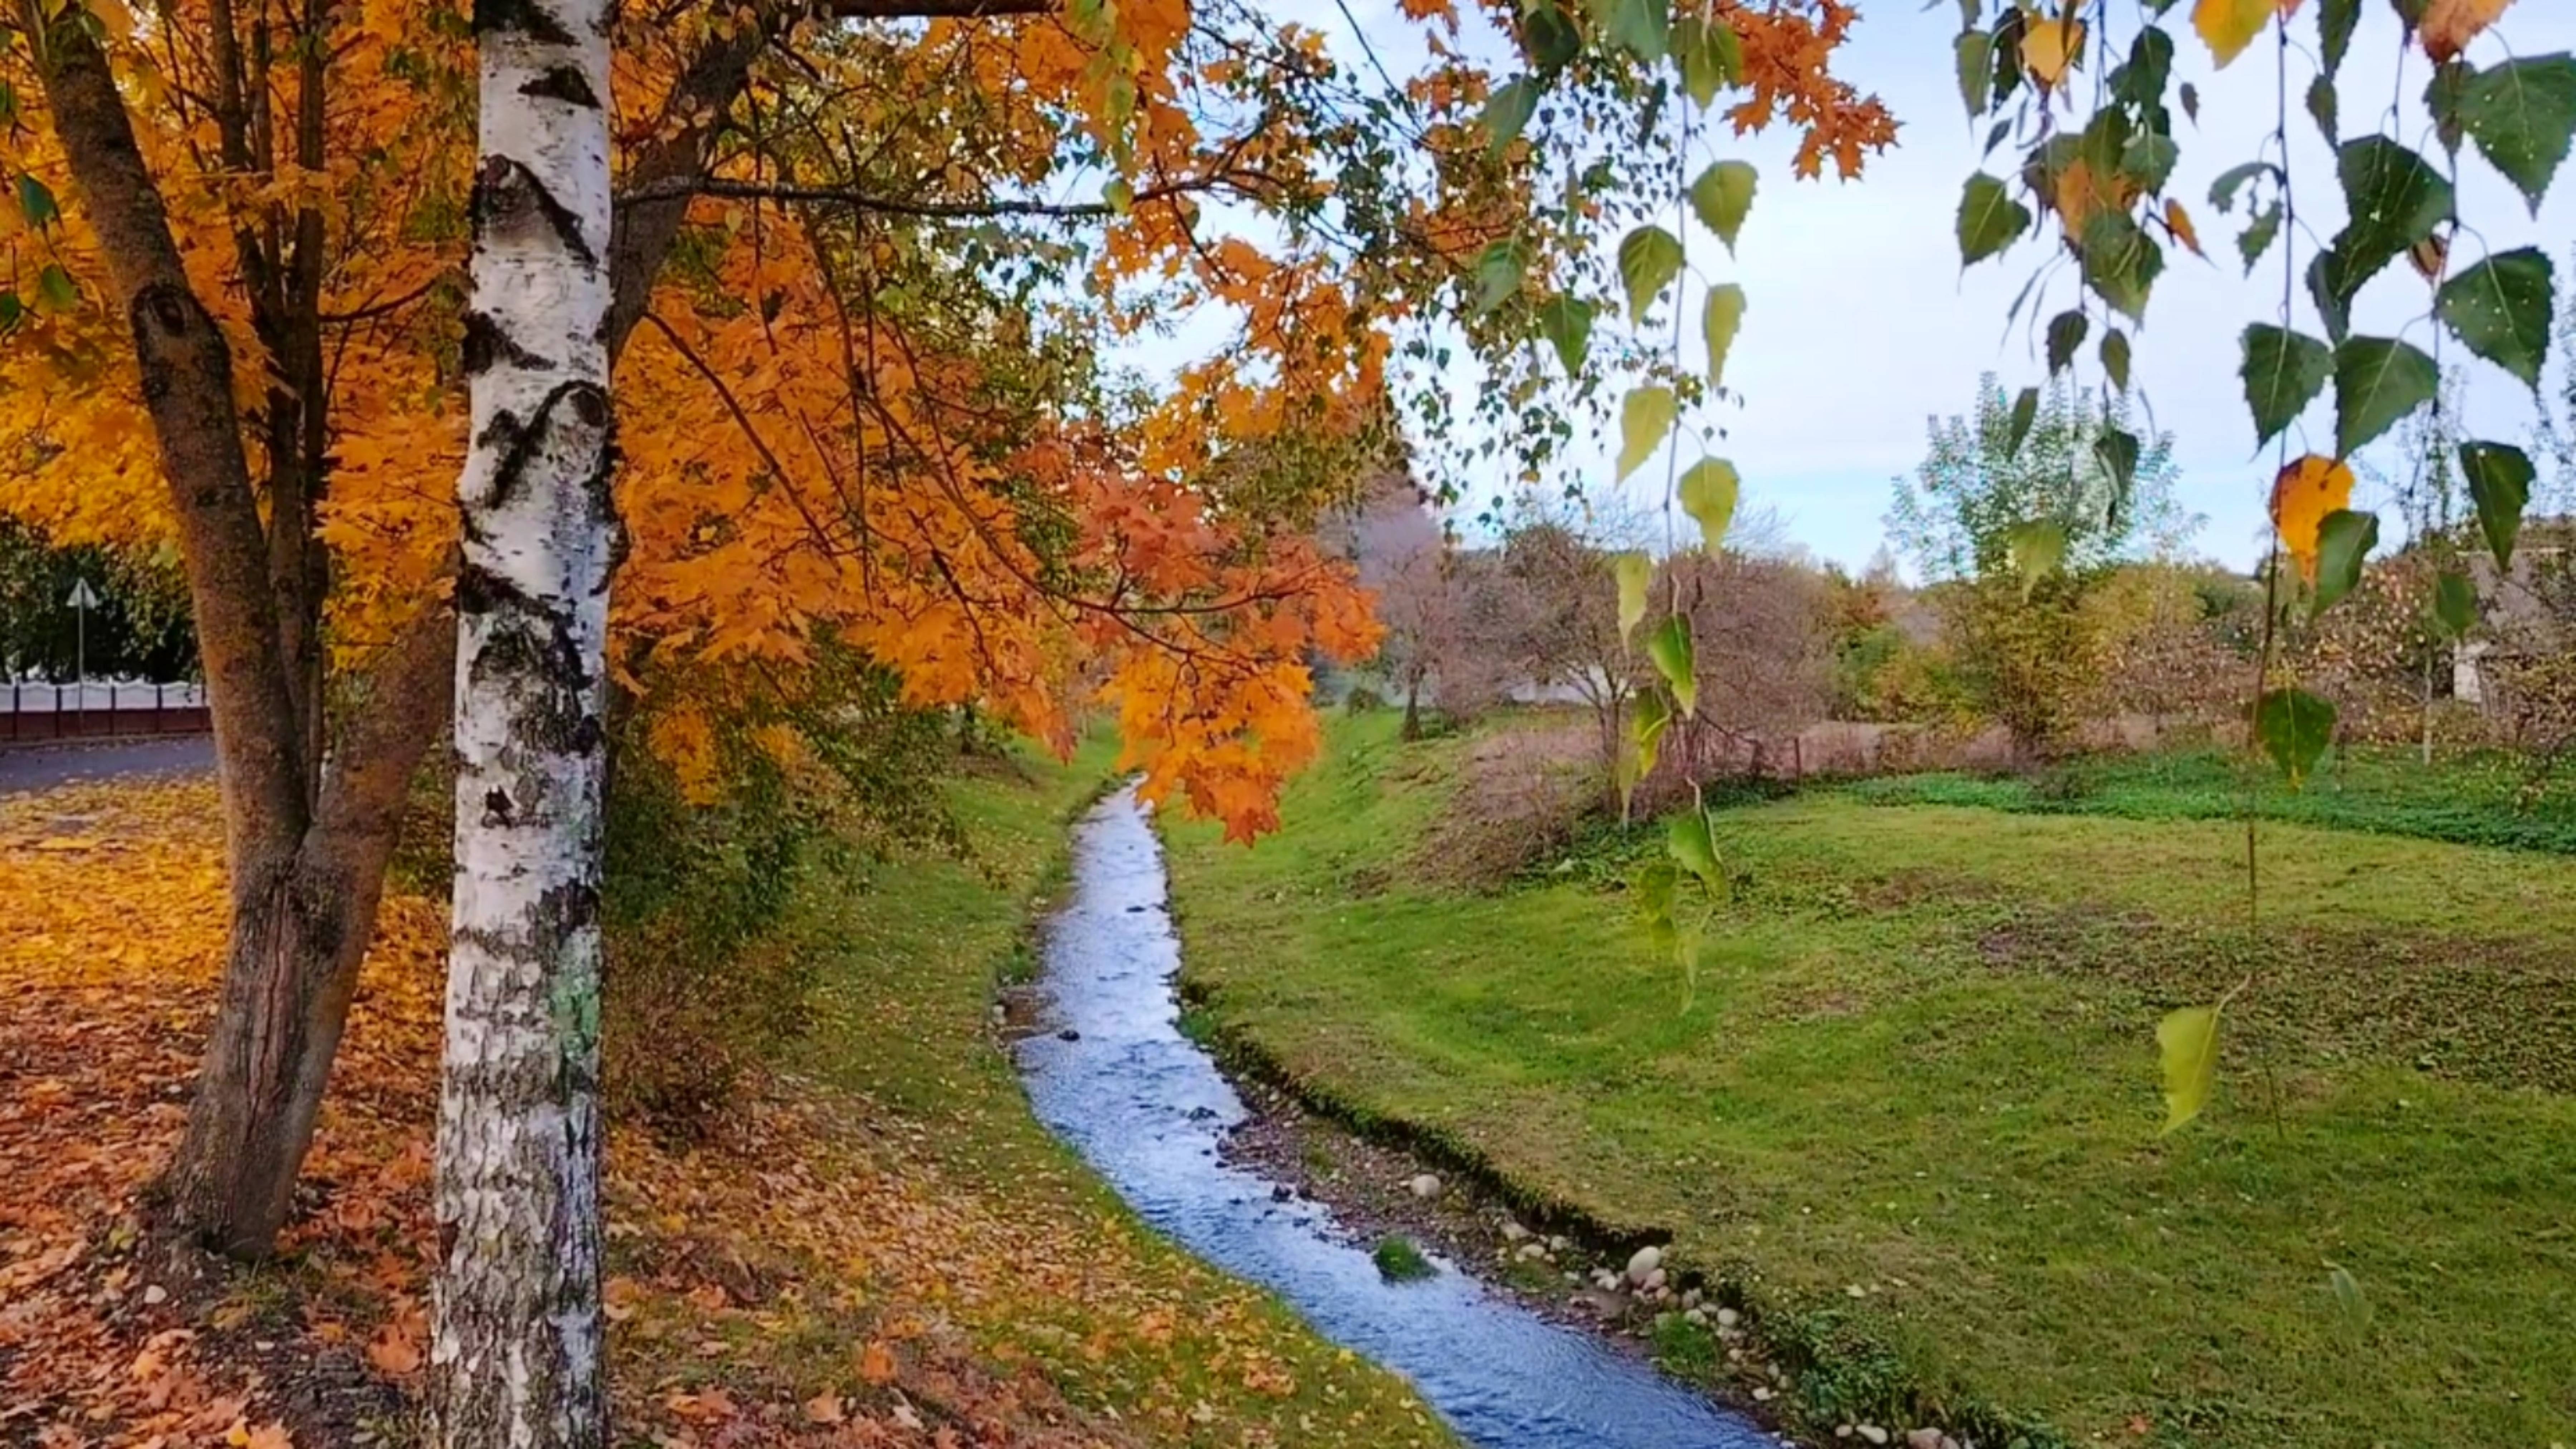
[1020,791,1775,1449]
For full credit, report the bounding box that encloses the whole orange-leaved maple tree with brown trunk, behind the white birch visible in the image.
[0,0,1893,1253]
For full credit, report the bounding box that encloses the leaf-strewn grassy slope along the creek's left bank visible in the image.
[783,745,1455,1449]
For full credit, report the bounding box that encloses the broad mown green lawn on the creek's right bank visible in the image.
[1170,717,2576,1449]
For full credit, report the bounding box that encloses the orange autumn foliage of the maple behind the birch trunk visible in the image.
[0,0,1891,835]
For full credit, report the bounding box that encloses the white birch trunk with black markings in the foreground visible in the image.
[430,0,613,1449]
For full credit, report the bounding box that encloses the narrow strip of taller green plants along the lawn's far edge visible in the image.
[1842,748,2576,856]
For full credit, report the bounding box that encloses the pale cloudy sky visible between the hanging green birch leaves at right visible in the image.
[1146,0,2576,567]
